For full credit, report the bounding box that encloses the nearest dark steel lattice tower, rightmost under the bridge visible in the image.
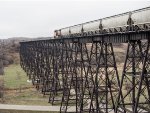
[116,40,149,113]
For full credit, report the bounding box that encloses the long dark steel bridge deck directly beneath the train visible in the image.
[20,31,150,43]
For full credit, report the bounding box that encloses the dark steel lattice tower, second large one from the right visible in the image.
[89,42,119,113]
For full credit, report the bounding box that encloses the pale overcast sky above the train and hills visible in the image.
[0,0,150,39]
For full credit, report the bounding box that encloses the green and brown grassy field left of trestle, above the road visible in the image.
[0,64,50,105]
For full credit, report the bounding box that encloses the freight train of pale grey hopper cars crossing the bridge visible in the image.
[54,7,150,38]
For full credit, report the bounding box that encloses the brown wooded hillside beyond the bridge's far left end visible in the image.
[0,37,50,75]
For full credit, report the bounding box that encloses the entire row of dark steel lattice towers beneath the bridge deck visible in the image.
[20,34,150,113]
